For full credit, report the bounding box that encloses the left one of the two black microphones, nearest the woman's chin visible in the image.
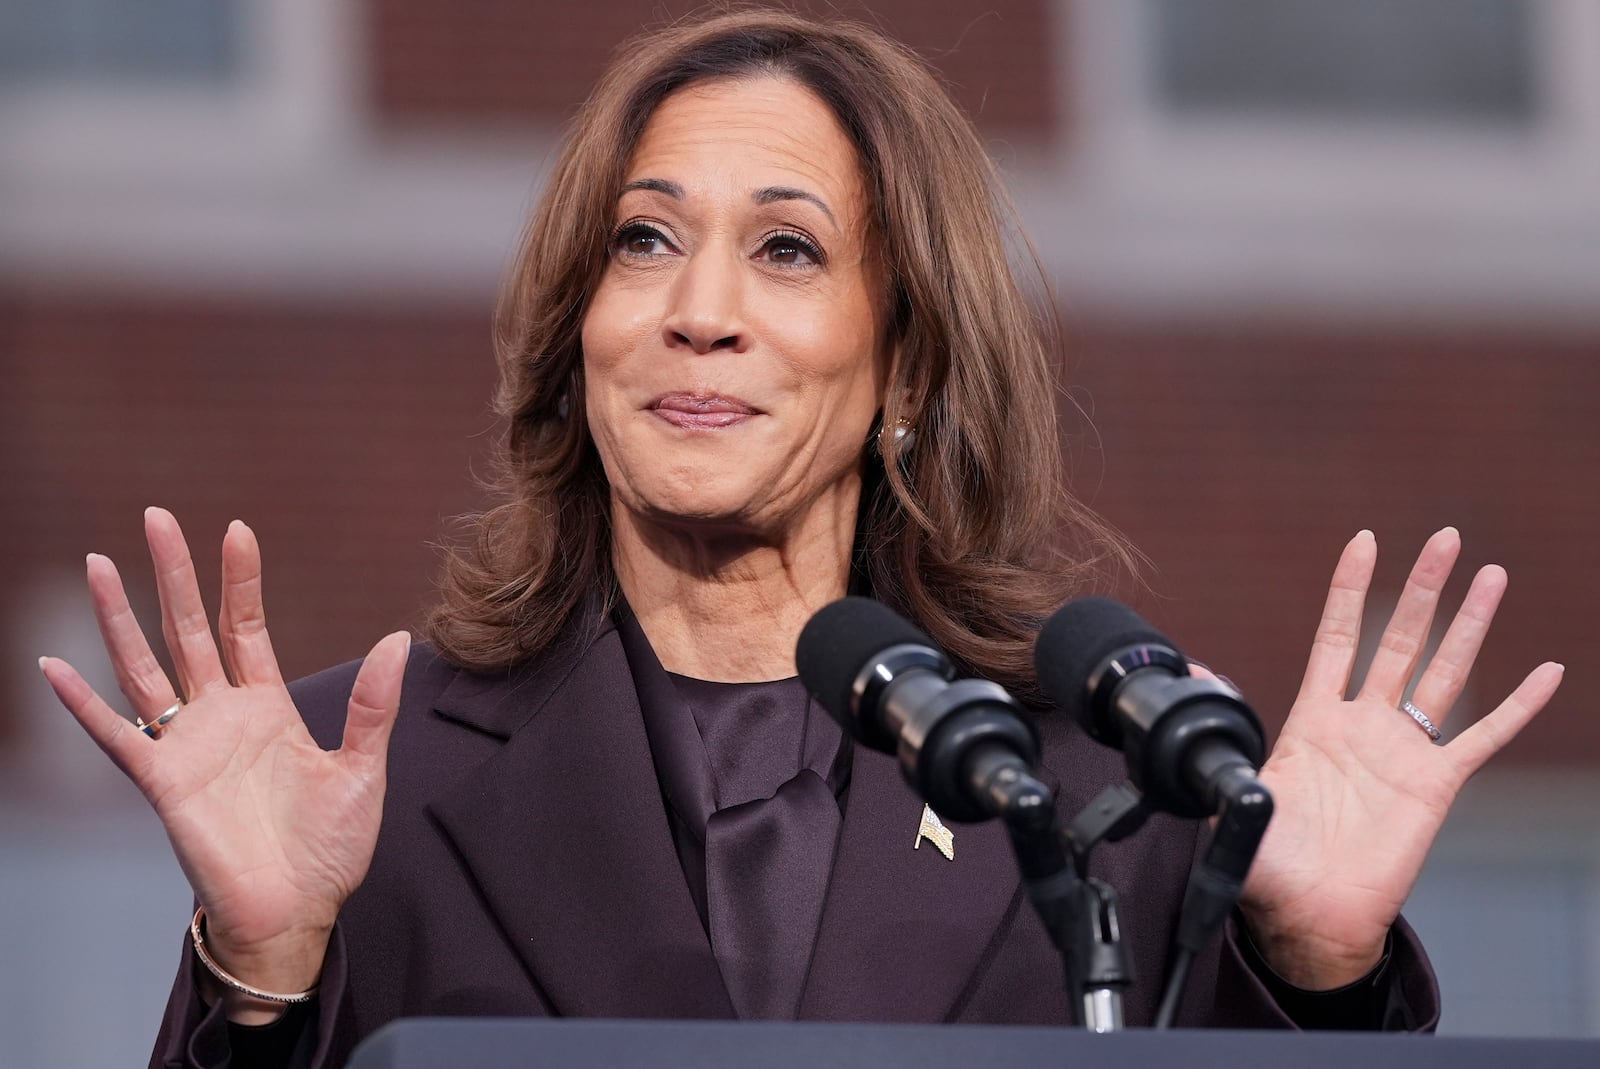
[795,597,1054,832]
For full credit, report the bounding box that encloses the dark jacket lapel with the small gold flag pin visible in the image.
[800,746,1019,1023]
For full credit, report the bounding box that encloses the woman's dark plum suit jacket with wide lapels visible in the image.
[152,604,1438,1066]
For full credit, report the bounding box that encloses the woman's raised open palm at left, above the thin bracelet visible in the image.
[40,509,411,1019]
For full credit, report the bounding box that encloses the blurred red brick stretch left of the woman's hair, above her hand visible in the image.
[0,289,493,742]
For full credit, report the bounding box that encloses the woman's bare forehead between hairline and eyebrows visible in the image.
[624,77,866,222]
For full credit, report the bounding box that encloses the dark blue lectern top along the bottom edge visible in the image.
[350,1018,1600,1069]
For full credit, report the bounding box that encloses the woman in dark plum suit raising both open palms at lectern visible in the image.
[42,13,1560,1066]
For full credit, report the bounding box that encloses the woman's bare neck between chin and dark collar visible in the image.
[611,498,856,683]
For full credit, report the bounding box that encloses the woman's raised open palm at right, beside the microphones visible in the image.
[1240,526,1562,989]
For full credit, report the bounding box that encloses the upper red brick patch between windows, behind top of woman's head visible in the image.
[366,0,1056,136]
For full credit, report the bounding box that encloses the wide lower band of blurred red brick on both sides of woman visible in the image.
[0,294,1600,763]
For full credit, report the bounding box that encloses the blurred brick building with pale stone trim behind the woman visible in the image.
[0,0,1600,1066]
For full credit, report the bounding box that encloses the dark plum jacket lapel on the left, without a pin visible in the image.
[429,623,733,1018]
